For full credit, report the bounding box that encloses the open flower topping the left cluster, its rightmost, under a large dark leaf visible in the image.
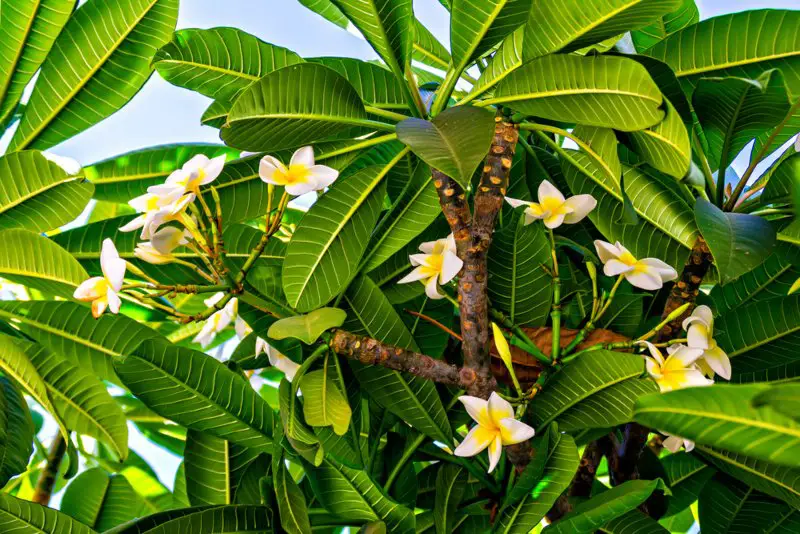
[258,146,339,196]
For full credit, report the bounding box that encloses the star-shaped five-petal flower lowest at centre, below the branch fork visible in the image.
[453,392,534,473]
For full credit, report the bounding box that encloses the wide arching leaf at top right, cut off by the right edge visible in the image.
[646,9,800,98]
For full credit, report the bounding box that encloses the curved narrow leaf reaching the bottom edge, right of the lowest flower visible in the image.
[492,434,580,534]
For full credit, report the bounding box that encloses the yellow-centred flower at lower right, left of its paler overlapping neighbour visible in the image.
[641,341,714,393]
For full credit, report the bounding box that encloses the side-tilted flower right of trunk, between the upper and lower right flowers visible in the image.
[594,239,678,291]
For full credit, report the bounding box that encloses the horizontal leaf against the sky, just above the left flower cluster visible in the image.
[83,143,244,202]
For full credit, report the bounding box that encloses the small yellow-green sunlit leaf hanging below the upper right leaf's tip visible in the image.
[630,99,692,179]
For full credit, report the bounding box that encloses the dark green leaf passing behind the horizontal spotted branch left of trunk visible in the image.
[345,276,452,444]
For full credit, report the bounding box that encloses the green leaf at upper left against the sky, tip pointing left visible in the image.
[153,27,303,100]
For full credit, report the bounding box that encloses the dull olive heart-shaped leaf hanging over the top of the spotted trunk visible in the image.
[397,106,494,188]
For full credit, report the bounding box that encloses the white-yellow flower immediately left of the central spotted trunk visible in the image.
[397,234,464,299]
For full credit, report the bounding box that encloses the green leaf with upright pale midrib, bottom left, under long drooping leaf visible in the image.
[183,430,259,506]
